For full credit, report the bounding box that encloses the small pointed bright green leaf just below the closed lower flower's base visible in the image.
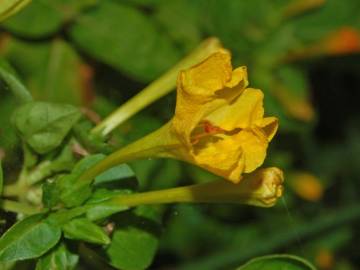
[62,218,110,245]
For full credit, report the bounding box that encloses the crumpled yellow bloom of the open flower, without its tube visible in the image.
[170,50,278,183]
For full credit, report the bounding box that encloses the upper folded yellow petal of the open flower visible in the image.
[172,50,248,147]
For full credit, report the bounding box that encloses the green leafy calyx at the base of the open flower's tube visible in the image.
[58,154,105,207]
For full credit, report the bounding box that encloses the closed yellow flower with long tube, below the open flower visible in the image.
[111,167,284,207]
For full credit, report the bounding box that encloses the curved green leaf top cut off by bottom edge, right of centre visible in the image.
[238,255,316,270]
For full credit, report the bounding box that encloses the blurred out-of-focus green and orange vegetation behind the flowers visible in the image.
[0,0,360,270]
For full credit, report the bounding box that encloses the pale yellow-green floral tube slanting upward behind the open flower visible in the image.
[92,38,221,136]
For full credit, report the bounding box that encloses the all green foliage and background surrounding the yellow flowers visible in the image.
[0,0,360,270]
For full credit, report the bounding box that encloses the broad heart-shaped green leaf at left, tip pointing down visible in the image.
[13,102,81,154]
